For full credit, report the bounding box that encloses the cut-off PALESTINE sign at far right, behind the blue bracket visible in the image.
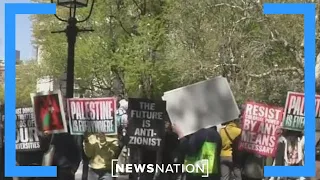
[283,92,320,131]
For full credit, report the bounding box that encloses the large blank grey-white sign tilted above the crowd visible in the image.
[162,77,240,136]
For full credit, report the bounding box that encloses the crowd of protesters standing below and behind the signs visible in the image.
[1,100,304,180]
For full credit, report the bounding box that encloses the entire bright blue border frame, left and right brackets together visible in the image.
[5,3,316,177]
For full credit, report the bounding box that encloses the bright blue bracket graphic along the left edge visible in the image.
[4,3,57,177]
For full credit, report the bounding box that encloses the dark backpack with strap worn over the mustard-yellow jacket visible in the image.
[223,128,246,165]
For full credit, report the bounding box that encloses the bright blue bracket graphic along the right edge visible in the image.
[263,3,316,177]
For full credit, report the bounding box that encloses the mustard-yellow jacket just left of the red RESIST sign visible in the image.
[220,122,241,157]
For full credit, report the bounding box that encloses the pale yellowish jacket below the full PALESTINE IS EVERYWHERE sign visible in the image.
[83,134,120,172]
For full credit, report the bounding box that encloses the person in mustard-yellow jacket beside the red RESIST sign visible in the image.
[220,121,243,180]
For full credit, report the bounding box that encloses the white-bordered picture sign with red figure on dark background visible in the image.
[30,91,68,133]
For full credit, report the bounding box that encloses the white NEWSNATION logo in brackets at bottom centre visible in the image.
[111,159,209,177]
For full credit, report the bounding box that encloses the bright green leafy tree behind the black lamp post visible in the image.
[33,1,176,97]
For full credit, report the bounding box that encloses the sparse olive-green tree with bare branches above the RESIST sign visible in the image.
[168,0,320,106]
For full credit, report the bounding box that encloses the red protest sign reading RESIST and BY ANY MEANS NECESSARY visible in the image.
[239,102,283,157]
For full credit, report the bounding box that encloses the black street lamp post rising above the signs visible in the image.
[51,0,95,98]
